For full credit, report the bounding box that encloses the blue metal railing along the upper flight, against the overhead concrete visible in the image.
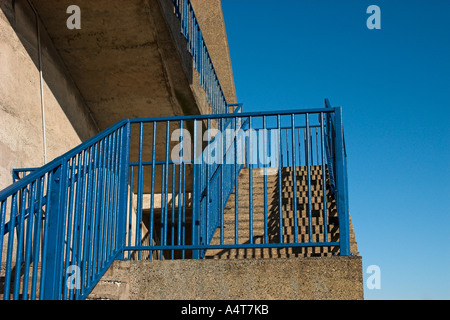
[172,0,228,114]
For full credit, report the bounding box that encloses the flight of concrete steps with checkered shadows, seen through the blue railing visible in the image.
[205,166,358,259]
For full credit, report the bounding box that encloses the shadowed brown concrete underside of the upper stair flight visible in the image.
[28,0,225,193]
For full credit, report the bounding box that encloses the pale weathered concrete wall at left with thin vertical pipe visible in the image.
[0,0,98,190]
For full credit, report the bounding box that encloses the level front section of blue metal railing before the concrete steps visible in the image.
[124,108,350,259]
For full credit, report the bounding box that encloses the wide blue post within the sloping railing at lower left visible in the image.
[42,160,67,300]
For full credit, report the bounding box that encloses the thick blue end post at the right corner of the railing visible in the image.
[334,107,350,256]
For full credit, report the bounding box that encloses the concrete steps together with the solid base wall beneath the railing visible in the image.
[88,166,362,300]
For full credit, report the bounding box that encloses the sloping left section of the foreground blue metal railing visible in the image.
[0,121,129,300]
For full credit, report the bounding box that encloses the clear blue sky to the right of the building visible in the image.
[222,0,450,299]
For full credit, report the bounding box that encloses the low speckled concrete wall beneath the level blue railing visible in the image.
[89,257,364,300]
